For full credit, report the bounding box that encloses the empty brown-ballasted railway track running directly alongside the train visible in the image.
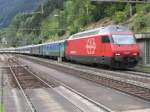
[17,54,150,101]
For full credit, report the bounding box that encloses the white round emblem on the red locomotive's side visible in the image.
[86,38,96,54]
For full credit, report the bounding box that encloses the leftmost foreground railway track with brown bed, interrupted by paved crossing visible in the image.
[9,55,113,112]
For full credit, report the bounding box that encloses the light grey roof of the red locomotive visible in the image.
[69,25,131,39]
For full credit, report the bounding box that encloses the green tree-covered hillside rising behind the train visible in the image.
[0,0,150,47]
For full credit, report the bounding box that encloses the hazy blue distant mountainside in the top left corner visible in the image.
[0,0,46,29]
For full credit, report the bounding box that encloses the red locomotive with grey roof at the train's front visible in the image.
[65,25,140,68]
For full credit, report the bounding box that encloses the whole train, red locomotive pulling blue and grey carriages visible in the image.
[0,25,140,68]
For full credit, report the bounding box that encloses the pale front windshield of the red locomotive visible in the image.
[112,35,136,44]
